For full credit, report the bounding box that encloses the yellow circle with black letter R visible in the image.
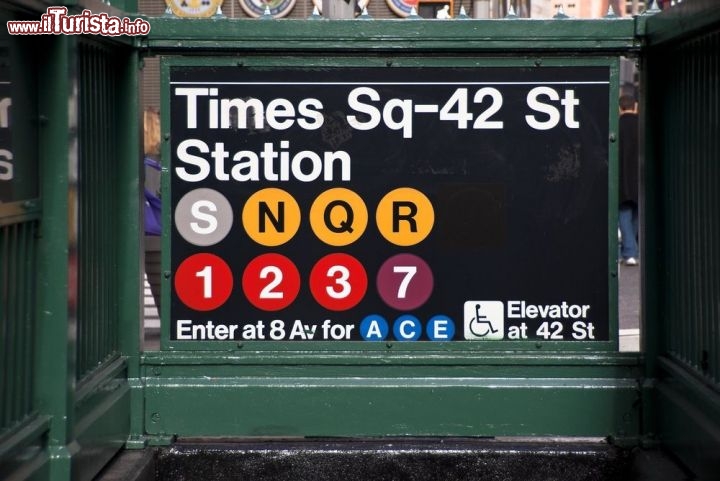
[375,187,435,246]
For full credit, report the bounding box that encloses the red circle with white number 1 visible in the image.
[175,253,233,311]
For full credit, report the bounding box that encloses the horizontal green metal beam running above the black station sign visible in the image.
[140,17,639,55]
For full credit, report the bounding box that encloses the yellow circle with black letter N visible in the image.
[242,188,300,247]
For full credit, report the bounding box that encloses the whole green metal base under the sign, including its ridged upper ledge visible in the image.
[141,351,641,439]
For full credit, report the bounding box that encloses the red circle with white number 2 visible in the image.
[242,253,300,311]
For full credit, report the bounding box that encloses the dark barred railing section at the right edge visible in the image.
[660,29,720,390]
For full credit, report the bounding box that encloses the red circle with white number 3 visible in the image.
[310,253,367,311]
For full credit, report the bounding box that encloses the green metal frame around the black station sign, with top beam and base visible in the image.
[134,18,641,444]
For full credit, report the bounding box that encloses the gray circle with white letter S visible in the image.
[175,188,233,246]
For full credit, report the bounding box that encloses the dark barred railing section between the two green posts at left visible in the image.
[77,39,122,379]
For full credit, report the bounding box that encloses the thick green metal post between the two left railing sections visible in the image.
[35,35,77,481]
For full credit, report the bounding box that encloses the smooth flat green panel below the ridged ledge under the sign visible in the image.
[145,377,639,437]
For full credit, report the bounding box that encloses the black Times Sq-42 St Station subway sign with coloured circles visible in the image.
[163,60,617,350]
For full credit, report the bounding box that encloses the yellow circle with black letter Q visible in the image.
[310,187,368,246]
